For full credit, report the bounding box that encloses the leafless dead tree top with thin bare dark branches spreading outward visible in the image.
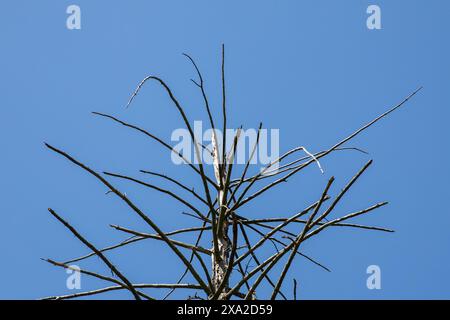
[45,45,421,300]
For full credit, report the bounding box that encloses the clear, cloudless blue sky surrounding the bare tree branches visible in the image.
[0,0,450,299]
